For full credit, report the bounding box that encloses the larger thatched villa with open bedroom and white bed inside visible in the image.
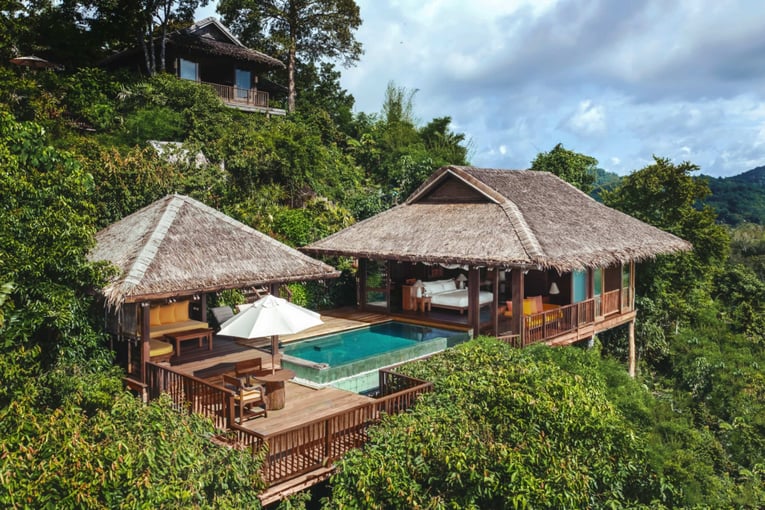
[302,166,691,374]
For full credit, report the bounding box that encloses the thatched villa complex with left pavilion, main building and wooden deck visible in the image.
[90,166,691,504]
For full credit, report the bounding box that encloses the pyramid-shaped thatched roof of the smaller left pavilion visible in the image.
[89,195,339,306]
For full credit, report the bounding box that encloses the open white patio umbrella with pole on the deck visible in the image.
[218,294,324,372]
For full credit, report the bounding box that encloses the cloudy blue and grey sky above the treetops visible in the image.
[197,0,765,177]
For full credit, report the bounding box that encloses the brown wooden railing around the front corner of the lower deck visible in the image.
[147,363,433,486]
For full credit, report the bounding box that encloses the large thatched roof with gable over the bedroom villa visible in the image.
[302,166,691,272]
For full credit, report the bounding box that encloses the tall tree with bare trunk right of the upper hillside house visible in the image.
[218,0,362,112]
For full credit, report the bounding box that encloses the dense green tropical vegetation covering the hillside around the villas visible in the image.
[0,0,765,508]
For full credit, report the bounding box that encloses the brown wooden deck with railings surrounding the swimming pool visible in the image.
[140,300,635,504]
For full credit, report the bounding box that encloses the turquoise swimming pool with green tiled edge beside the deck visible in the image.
[282,321,469,393]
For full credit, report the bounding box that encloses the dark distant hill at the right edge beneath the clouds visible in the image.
[700,166,765,226]
